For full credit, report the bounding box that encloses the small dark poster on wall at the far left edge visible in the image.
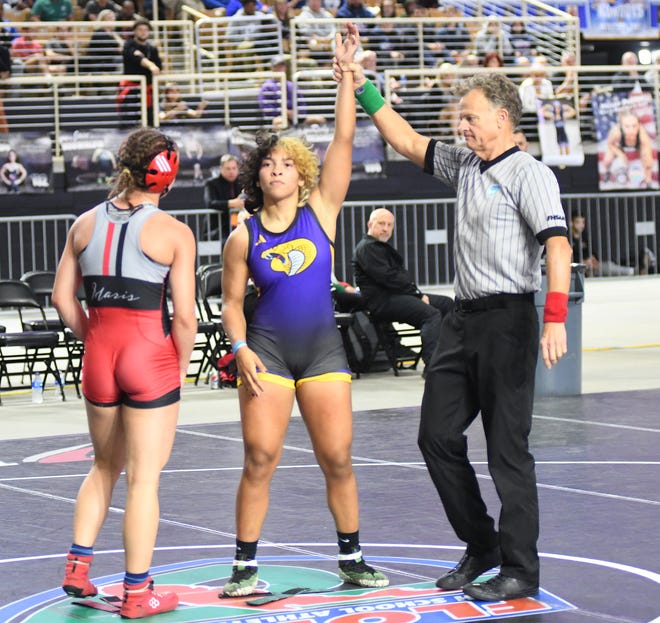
[0,133,53,195]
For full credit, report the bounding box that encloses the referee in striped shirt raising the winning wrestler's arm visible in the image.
[334,48,571,601]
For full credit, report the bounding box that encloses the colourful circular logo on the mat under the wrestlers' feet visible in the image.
[0,556,573,623]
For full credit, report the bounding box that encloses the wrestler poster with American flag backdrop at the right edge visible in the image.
[592,91,660,190]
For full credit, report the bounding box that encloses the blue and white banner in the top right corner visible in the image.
[582,0,658,39]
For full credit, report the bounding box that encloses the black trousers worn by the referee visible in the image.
[418,295,539,583]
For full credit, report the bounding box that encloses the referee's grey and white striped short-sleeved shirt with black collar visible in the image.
[424,140,568,299]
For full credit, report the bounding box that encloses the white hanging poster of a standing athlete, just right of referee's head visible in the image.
[536,97,584,167]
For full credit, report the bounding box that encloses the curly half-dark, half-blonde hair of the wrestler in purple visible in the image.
[239,130,320,214]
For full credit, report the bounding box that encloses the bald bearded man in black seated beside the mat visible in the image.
[353,208,454,363]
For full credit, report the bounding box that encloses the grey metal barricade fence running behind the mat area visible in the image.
[0,192,660,286]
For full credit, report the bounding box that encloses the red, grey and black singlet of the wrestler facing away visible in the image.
[79,201,181,409]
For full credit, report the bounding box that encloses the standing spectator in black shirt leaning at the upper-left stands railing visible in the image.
[117,19,163,127]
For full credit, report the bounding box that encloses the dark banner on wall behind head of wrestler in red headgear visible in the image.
[60,125,229,190]
